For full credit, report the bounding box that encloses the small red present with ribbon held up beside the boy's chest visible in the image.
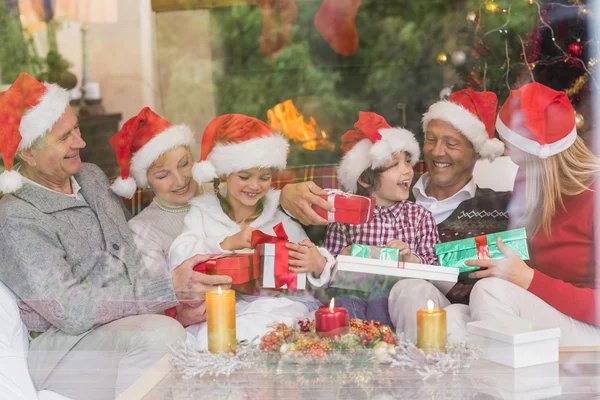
[312,189,375,225]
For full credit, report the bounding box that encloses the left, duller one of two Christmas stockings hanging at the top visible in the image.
[258,0,298,58]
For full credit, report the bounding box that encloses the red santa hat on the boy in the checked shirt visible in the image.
[338,111,420,192]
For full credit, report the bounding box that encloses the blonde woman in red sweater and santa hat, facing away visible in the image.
[467,83,600,346]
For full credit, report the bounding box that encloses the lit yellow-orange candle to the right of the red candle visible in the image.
[417,300,447,352]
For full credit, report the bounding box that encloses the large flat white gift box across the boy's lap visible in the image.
[330,255,459,293]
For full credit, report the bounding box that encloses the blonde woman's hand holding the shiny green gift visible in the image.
[465,238,533,290]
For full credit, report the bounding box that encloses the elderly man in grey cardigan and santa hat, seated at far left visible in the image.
[0,73,228,399]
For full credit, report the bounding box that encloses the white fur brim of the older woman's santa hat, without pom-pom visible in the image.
[130,125,194,188]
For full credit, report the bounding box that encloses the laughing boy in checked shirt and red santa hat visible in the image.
[324,112,439,326]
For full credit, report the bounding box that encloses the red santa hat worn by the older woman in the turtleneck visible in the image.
[110,107,194,199]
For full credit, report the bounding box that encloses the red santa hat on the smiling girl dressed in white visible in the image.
[192,114,289,183]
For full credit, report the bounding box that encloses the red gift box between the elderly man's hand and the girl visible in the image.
[194,252,260,294]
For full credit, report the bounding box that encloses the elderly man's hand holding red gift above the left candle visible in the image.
[171,254,231,307]
